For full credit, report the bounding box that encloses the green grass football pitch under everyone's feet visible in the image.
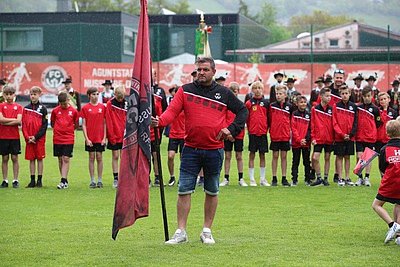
[0,131,400,266]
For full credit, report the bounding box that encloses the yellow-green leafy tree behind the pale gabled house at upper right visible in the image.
[288,10,353,36]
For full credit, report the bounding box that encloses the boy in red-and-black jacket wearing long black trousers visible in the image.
[290,96,311,186]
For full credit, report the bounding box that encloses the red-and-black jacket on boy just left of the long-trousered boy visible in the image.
[268,102,292,142]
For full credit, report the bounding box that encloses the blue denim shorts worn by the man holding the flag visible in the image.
[178,146,224,195]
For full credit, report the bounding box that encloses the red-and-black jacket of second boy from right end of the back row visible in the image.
[356,103,381,143]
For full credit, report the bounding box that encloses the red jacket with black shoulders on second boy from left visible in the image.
[22,102,48,141]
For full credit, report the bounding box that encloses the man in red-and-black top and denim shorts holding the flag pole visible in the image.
[152,57,247,244]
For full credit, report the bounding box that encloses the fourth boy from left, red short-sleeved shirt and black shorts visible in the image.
[81,87,106,188]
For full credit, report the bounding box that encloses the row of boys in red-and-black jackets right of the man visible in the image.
[220,76,397,186]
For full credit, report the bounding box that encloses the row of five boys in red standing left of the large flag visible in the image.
[0,86,127,189]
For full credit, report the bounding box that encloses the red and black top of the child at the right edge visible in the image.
[378,139,400,199]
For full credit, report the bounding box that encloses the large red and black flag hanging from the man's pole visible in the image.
[112,0,151,240]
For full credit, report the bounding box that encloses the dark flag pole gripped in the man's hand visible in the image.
[151,84,169,241]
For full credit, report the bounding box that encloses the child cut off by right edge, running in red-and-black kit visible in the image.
[372,120,400,245]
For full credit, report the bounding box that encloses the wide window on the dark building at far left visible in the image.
[3,28,43,51]
